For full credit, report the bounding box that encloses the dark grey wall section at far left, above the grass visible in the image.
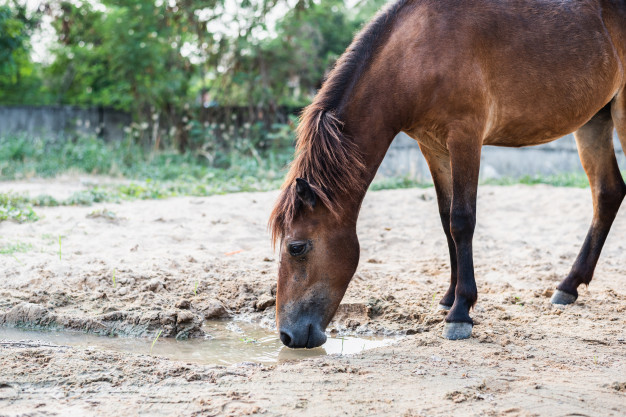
[0,106,131,140]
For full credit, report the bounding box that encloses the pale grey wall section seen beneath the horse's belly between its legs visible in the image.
[378,133,626,181]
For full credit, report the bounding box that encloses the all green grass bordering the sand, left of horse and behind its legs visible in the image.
[0,135,589,222]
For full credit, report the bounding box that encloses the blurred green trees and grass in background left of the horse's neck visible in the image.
[0,0,394,221]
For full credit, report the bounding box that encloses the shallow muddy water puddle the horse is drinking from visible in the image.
[0,320,397,365]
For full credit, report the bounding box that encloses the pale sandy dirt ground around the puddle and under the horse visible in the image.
[0,181,626,416]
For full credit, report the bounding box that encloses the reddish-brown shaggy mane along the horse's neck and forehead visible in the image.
[268,0,411,245]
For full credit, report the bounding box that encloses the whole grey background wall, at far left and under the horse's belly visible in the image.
[0,106,626,181]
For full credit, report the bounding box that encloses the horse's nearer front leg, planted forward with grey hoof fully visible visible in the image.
[443,135,481,340]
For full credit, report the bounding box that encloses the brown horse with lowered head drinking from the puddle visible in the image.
[270,0,626,348]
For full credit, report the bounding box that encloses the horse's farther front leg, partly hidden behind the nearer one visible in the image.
[420,144,457,310]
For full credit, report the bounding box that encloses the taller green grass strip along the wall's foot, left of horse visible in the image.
[0,135,293,182]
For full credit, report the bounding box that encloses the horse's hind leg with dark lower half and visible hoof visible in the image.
[551,102,626,304]
